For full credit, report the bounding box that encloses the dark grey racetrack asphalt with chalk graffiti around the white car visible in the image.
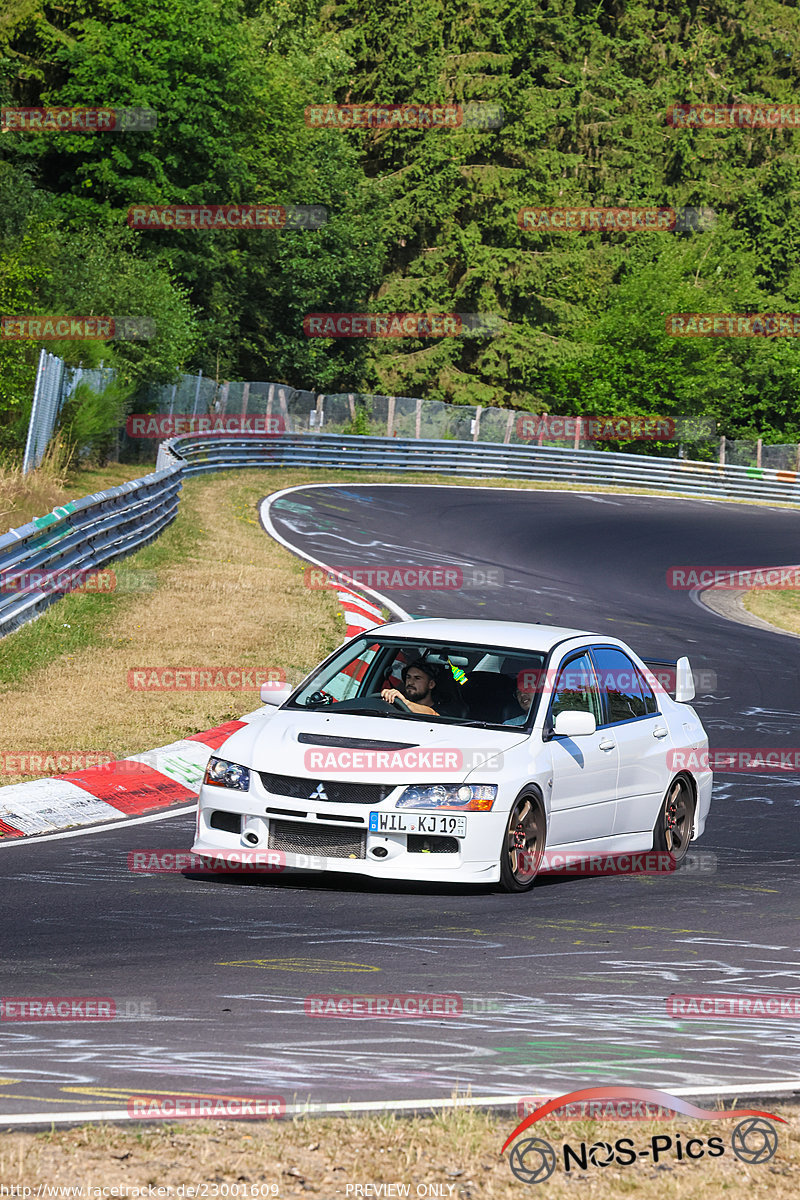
[0,485,800,1124]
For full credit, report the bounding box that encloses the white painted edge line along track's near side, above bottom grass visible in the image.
[0,1079,800,1129]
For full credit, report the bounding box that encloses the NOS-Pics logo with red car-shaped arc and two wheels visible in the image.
[503,1087,786,1183]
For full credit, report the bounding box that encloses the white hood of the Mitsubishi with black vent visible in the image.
[213,708,528,784]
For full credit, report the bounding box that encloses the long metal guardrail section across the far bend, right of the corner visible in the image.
[158,433,800,505]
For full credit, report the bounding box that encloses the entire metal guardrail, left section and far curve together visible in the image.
[0,433,800,636]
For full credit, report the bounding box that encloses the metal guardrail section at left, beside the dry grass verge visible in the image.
[0,463,184,637]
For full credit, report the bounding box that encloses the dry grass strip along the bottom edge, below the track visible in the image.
[0,1105,800,1200]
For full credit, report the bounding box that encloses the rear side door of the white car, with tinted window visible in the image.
[591,646,672,834]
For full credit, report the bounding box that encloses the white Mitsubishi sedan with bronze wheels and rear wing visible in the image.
[192,618,712,892]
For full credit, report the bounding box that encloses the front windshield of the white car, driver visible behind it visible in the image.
[289,632,545,727]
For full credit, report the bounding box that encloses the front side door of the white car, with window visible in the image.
[545,650,619,850]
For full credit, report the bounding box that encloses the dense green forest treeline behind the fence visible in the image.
[0,0,800,455]
